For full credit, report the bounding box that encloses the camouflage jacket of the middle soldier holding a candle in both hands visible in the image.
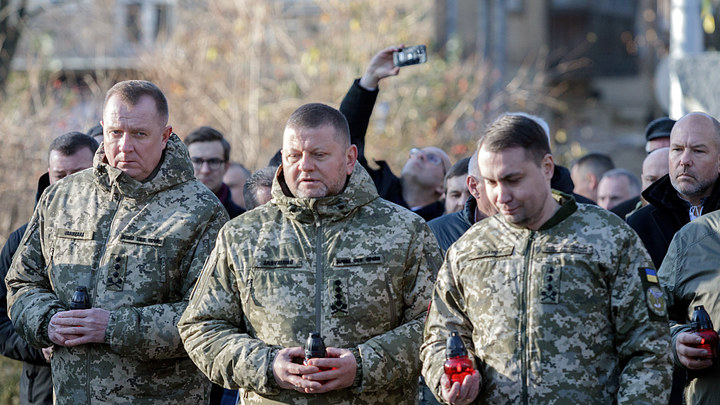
[178,165,442,404]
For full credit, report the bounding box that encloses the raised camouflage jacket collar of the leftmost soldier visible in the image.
[93,134,195,199]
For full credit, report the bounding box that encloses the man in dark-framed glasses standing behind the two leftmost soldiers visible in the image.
[185,127,245,218]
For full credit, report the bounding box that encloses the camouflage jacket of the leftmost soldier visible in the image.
[6,135,227,405]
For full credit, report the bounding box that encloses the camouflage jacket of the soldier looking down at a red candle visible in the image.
[421,191,671,405]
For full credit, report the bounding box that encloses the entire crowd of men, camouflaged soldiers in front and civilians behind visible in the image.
[0,46,720,405]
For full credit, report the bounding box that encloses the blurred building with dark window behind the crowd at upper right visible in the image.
[435,0,670,173]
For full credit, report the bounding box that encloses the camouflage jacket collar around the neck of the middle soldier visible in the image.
[272,164,379,223]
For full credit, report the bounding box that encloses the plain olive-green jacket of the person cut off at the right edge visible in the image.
[658,211,720,404]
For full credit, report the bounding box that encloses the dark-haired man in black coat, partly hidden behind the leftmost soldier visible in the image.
[0,132,98,405]
